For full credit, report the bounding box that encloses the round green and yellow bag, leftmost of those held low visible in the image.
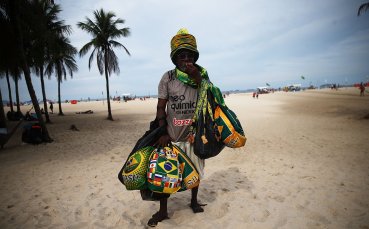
[121,146,155,190]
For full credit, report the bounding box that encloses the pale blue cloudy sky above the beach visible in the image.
[0,0,369,101]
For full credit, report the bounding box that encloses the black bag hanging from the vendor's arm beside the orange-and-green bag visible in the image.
[194,90,225,159]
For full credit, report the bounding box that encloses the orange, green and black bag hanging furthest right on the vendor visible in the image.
[214,105,246,148]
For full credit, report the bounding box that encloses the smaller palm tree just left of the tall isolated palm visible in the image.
[45,36,78,115]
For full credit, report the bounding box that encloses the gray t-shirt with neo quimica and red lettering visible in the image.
[158,70,198,142]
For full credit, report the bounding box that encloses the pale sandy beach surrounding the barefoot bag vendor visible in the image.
[0,88,369,229]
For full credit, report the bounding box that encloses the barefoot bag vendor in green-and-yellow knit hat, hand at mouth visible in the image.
[148,29,205,227]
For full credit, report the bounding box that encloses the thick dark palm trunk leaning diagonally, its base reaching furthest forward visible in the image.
[9,0,53,142]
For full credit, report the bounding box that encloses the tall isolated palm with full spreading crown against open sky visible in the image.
[77,9,131,120]
